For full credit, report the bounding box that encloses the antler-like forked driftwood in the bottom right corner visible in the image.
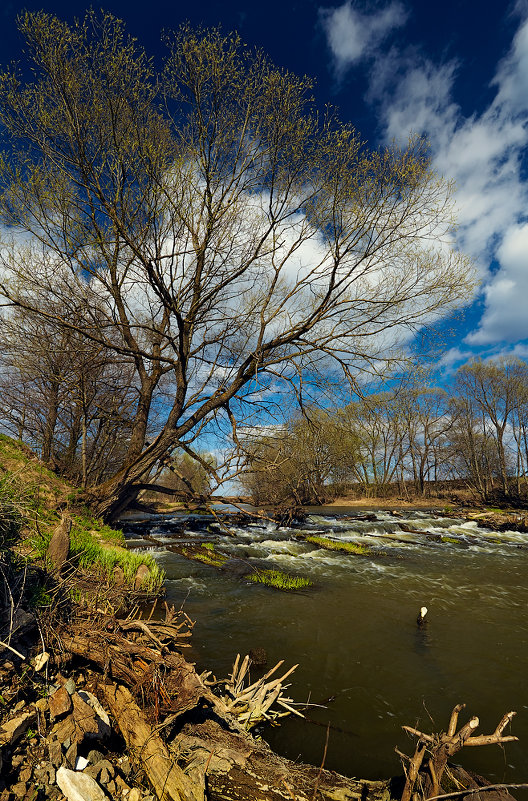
[396,704,518,801]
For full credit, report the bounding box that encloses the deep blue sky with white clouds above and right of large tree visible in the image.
[0,0,528,373]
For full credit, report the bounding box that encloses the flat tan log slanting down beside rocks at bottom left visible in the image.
[102,684,205,801]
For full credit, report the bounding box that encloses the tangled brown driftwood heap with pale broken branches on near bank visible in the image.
[60,615,389,801]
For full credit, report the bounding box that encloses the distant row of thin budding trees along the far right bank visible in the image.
[242,359,528,504]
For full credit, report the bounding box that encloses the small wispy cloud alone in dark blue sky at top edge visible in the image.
[320,0,407,74]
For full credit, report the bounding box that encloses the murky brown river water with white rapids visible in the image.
[120,510,528,784]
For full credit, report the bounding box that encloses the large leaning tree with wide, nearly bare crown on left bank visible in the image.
[0,12,470,517]
